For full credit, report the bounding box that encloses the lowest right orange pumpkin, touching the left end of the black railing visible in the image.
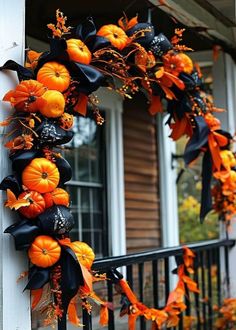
[71,241,95,269]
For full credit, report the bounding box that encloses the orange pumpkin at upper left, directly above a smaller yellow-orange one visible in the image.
[37,62,70,92]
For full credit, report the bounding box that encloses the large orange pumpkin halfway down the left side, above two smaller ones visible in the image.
[22,158,60,193]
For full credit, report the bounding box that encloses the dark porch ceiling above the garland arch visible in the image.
[26,0,212,50]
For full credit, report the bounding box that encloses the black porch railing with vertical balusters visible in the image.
[80,240,235,330]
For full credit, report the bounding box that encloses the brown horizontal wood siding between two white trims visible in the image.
[123,98,160,252]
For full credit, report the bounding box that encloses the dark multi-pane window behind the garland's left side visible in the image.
[64,117,108,257]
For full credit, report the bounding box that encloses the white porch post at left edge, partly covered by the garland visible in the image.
[0,0,31,330]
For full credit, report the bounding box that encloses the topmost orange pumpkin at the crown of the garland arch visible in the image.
[97,24,129,50]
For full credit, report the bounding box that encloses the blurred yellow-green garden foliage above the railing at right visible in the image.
[176,63,219,243]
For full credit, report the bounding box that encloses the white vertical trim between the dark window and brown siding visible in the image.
[95,88,126,256]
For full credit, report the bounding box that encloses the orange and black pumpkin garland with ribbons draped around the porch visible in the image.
[0,10,236,326]
